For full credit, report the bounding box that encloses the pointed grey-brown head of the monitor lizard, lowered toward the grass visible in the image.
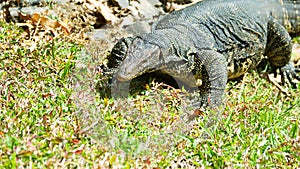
[117,38,164,82]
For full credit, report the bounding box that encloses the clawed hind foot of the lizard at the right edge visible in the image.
[280,63,300,88]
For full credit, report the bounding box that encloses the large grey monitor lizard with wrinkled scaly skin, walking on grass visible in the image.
[109,0,300,108]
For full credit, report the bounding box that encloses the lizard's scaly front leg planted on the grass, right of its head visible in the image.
[193,50,228,110]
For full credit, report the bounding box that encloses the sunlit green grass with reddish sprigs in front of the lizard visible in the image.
[0,23,300,168]
